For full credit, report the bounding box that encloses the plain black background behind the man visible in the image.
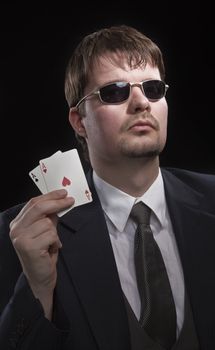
[0,1,215,210]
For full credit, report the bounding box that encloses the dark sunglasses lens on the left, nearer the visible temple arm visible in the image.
[100,82,130,103]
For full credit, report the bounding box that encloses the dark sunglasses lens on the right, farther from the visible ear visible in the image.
[143,80,165,100]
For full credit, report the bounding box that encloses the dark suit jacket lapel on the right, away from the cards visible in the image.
[162,170,215,336]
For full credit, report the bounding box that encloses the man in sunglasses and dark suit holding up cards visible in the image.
[0,26,215,350]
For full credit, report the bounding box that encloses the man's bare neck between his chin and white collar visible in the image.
[92,157,159,197]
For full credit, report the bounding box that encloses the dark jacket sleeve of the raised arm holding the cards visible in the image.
[0,207,67,350]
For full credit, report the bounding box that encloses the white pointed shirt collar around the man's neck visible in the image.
[93,169,166,232]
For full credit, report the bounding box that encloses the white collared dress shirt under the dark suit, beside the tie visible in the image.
[93,170,184,334]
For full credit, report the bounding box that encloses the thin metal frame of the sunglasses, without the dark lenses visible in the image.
[74,79,169,109]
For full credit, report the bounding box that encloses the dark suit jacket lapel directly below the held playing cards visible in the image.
[55,174,129,350]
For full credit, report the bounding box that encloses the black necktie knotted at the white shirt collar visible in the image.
[131,202,176,349]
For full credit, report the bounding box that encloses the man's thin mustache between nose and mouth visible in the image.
[121,112,160,131]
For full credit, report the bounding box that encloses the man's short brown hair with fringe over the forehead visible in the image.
[65,25,165,158]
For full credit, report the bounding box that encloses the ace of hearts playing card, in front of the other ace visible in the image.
[40,149,92,216]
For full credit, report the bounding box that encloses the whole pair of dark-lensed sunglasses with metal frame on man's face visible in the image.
[75,80,169,108]
